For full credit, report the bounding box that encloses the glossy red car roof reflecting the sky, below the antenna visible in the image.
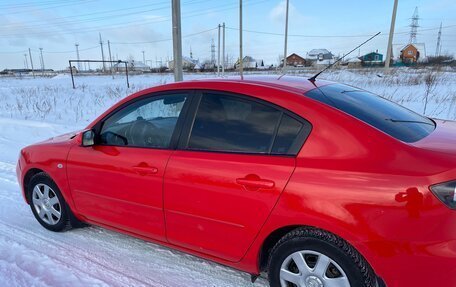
[166,75,333,93]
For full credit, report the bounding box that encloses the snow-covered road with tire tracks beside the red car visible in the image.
[0,118,267,287]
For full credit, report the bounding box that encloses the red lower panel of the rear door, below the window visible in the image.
[164,151,295,262]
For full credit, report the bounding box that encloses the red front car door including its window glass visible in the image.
[67,92,189,240]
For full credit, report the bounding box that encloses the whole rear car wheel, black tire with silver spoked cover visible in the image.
[268,228,378,287]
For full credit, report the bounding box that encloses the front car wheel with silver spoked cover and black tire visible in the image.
[27,172,72,232]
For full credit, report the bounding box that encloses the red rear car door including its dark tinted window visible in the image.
[164,92,310,261]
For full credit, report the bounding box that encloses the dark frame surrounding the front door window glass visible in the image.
[93,90,194,150]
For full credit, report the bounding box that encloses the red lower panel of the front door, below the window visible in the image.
[67,145,172,240]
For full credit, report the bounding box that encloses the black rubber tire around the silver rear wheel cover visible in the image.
[268,227,378,287]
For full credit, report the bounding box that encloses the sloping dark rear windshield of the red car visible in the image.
[306,84,435,142]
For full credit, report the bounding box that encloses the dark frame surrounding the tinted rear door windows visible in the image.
[177,89,312,157]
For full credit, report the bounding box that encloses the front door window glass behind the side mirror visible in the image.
[100,94,187,148]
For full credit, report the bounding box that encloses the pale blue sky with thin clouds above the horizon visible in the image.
[0,0,456,70]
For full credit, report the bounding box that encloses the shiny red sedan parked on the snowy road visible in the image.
[17,76,456,287]
